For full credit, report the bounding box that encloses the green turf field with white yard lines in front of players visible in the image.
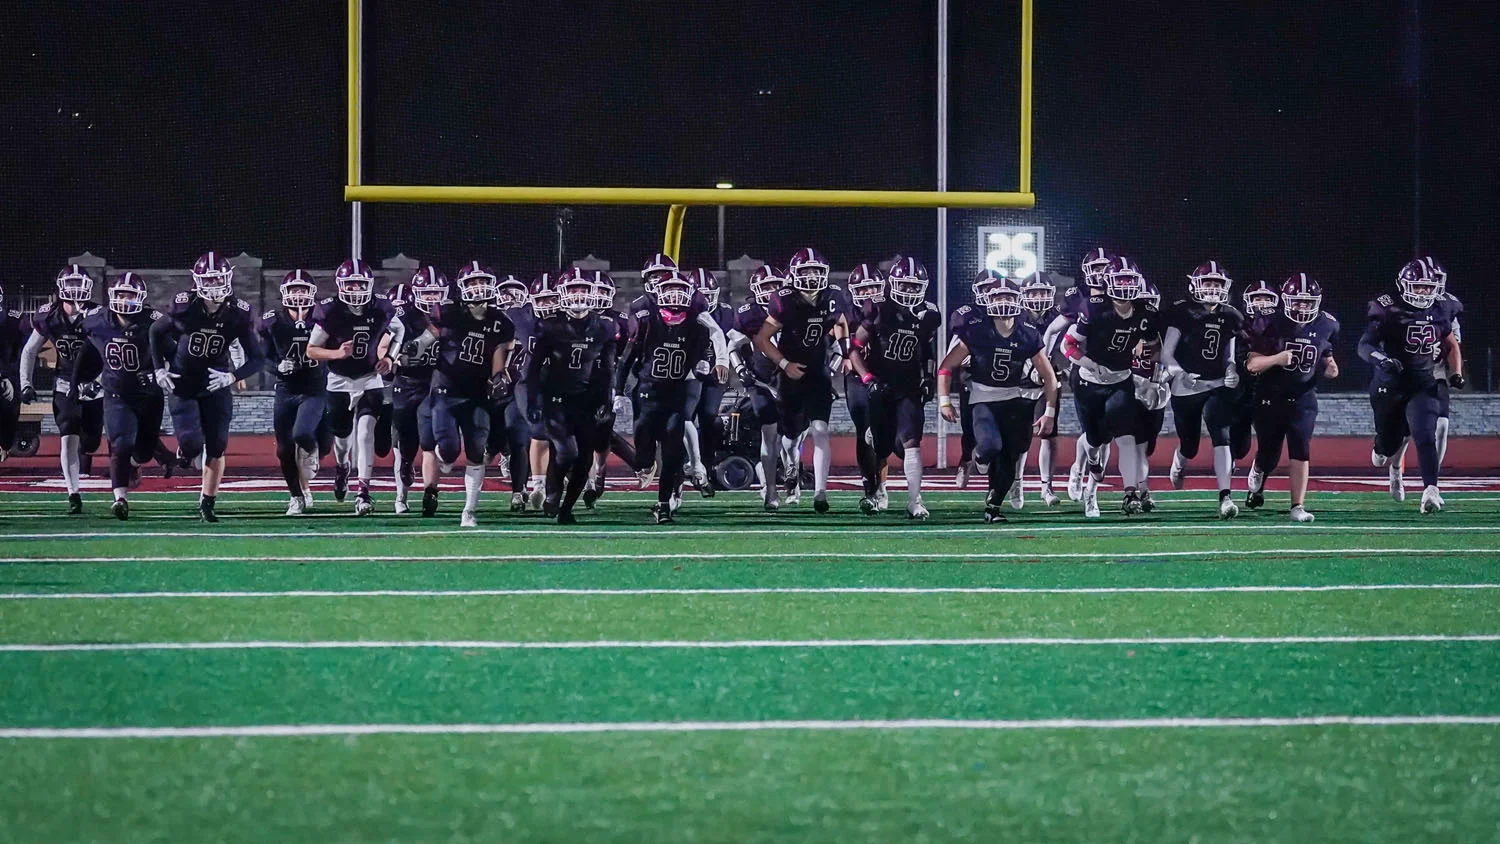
[0,492,1500,843]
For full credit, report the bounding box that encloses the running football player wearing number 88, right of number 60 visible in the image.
[152,252,264,522]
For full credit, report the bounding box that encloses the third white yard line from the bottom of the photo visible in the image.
[0,583,1500,601]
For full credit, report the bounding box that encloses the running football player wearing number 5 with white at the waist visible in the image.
[938,270,1058,522]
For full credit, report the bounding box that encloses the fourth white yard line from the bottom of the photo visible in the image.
[0,547,1500,565]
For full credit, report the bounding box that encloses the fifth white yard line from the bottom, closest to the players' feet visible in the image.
[6,516,1500,541]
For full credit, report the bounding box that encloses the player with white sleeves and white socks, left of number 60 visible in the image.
[20,264,104,516]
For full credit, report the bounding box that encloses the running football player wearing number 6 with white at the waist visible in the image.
[308,259,405,516]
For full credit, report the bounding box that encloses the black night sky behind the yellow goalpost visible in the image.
[0,0,1500,374]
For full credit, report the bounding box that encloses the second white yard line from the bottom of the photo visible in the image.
[0,633,1500,654]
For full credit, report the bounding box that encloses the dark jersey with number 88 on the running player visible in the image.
[152,292,264,396]
